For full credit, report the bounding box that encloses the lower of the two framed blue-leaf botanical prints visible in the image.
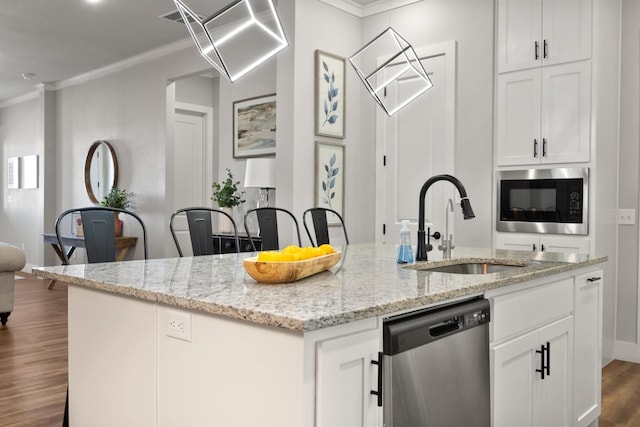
[315,141,345,225]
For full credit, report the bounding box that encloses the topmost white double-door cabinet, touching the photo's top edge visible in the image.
[497,0,592,73]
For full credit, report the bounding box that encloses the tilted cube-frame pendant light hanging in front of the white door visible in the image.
[349,28,433,116]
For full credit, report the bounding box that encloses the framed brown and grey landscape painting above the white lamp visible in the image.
[233,93,276,159]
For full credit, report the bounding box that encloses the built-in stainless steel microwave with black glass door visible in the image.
[496,168,589,235]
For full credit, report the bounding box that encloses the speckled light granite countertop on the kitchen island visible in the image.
[33,243,607,331]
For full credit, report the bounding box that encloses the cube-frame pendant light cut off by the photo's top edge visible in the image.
[174,0,288,82]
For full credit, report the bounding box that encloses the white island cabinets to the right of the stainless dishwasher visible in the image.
[486,270,603,427]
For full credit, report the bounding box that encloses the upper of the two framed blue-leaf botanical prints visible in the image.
[315,50,347,138]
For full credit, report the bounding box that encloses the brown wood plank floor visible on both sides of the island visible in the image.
[0,275,640,427]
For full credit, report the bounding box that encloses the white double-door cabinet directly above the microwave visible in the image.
[496,61,591,166]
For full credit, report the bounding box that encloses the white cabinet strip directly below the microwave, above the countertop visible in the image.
[496,233,590,254]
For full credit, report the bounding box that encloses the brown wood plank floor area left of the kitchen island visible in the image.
[0,275,67,427]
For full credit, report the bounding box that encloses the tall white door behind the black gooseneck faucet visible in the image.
[376,43,459,246]
